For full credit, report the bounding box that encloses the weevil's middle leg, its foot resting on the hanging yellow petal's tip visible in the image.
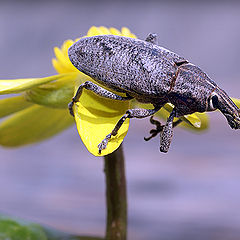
[98,106,162,154]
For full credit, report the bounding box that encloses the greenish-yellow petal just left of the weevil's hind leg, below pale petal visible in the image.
[25,72,83,108]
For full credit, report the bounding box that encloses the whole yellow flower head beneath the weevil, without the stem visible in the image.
[0,27,208,156]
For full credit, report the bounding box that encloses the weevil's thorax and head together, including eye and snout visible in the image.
[169,63,240,129]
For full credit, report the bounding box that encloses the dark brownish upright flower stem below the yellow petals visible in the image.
[104,145,127,240]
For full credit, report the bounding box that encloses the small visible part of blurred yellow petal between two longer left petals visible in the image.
[0,95,32,118]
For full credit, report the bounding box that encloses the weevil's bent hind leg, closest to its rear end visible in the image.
[68,81,133,116]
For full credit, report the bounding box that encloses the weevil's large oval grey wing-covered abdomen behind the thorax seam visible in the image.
[69,35,185,102]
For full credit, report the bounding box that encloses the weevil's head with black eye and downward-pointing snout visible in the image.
[208,88,240,129]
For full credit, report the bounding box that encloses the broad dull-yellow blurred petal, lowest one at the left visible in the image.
[0,105,74,147]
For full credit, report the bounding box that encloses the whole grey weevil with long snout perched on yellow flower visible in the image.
[68,34,240,153]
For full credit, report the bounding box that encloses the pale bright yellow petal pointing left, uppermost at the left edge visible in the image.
[0,75,67,94]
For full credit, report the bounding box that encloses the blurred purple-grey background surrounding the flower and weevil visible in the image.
[0,0,240,240]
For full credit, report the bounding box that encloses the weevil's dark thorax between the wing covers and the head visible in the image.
[169,63,217,115]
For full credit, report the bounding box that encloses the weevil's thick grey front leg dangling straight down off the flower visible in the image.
[160,108,176,153]
